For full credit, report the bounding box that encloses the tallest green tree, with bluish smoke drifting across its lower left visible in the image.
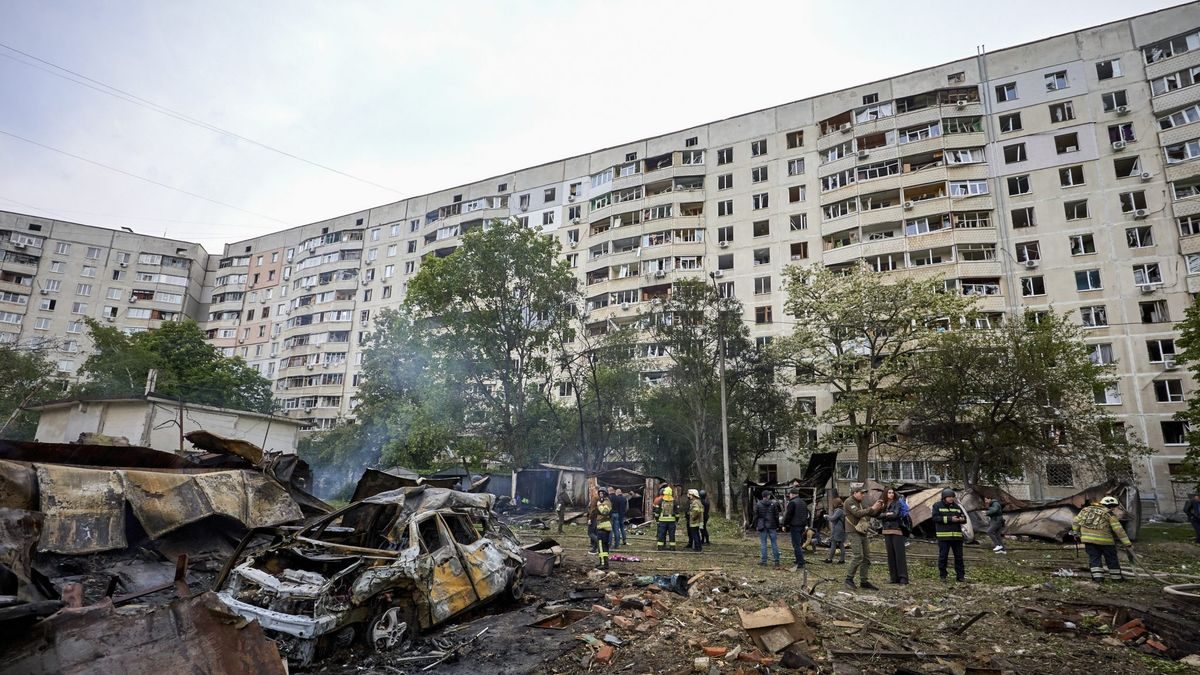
[369,220,576,465]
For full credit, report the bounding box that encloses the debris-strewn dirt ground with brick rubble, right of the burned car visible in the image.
[308,516,1200,675]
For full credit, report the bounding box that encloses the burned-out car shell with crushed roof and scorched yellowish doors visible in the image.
[216,485,524,665]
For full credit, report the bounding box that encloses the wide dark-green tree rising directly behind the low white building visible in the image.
[73,319,274,413]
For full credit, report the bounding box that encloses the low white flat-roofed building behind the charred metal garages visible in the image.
[30,394,304,453]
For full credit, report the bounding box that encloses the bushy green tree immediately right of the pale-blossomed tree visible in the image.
[900,311,1140,485]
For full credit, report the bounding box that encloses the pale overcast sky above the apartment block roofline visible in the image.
[0,0,1178,252]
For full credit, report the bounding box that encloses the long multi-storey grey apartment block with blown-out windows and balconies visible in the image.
[0,4,1200,510]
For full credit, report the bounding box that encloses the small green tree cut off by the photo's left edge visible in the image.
[0,345,62,441]
